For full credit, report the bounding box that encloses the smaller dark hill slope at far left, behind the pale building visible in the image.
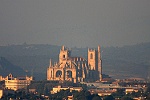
[0,57,26,76]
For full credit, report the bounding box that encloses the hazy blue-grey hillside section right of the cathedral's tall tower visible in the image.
[102,43,150,78]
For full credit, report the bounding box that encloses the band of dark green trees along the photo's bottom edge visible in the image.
[1,85,150,100]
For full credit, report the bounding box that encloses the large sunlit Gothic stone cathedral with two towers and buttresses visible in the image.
[47,46,102,83]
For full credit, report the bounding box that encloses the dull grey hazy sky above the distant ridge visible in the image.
[0,0,150,47]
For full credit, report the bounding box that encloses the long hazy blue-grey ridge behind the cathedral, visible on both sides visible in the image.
[0,43,150,79]
